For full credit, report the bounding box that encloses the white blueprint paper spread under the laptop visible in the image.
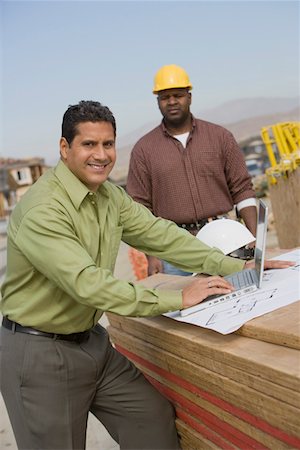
[165,249,300,334]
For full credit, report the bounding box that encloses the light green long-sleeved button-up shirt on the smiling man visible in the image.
[1,161,244,334]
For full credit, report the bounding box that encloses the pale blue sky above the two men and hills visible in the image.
[0,0,299,163]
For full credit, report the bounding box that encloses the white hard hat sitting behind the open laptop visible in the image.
[196,219,255,255]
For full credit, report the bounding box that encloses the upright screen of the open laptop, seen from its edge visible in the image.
[254,200,268,287]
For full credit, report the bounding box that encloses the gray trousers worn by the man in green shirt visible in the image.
[1,325,180,450]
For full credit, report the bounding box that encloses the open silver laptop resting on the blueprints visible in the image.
[180,200,268,317]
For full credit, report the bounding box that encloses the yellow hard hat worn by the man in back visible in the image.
[153,64,192,94]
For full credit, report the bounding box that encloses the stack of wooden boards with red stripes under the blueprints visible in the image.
[107,268,300,450]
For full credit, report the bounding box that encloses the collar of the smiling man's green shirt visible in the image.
[54,160,107,209]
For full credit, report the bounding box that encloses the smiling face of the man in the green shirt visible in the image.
[60,121,116,192]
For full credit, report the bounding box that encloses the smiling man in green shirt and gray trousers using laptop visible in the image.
[1,101,286,450]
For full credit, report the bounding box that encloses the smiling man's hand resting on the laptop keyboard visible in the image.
[182,276,234,308]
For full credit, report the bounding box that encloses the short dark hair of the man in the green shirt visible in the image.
[61,100,116,145]
